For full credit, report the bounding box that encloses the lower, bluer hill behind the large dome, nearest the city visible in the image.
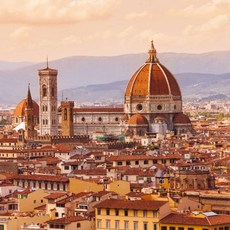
[59,73,230,103]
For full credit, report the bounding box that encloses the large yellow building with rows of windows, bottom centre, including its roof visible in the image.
[95,199,170,230]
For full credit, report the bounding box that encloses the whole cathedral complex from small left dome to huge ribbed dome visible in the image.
[12,42,192,137]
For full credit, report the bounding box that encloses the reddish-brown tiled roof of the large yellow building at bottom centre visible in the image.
[95,199,167,211]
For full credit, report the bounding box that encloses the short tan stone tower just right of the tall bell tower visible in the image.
[61,101,74,136]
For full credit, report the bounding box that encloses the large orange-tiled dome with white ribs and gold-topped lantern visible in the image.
[125,42,181,98]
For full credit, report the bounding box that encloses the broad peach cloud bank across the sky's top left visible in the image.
[0,0,119,25]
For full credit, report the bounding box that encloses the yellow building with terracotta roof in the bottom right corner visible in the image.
[160,212,230,230]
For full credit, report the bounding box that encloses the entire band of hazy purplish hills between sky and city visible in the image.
[0,51,230,104]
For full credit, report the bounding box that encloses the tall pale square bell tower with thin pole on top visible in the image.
[38,61,58,135]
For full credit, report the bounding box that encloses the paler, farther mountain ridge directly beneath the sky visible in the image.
[0,51,230,104]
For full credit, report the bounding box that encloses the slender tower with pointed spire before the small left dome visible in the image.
[25,85,34,140]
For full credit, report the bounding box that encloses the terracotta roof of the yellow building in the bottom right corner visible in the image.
[160,213,230,226]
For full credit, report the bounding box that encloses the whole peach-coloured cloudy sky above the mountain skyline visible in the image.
[0,0,230,61]
